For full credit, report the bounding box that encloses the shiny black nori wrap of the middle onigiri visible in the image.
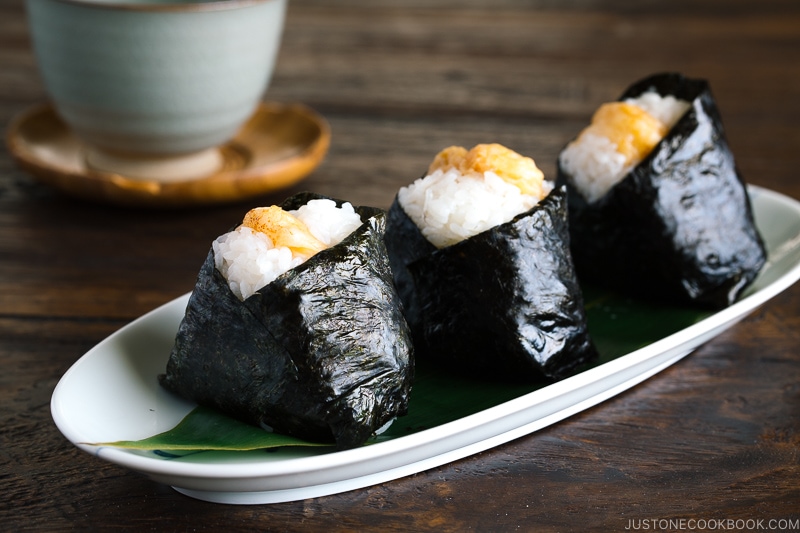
[385,185,597,382]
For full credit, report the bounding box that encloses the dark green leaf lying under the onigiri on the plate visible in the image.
[93,289,711,457]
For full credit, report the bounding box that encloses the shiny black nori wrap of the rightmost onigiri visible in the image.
[557,73,766,308]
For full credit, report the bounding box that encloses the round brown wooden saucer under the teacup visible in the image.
[6,103,330,207]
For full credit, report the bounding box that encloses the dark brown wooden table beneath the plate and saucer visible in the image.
[0,0,800,531]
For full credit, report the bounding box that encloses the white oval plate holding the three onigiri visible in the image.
[51,187,800,504]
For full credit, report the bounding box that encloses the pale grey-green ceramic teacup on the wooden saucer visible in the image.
[26,0,286,181]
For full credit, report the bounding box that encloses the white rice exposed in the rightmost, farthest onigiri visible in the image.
[559,91,691,203]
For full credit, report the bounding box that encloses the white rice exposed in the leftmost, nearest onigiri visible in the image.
[212,199,361,301]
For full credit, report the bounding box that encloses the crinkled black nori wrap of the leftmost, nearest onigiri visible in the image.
[159,193,414,449]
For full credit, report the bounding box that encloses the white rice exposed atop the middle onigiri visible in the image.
[397,169,552,248]
